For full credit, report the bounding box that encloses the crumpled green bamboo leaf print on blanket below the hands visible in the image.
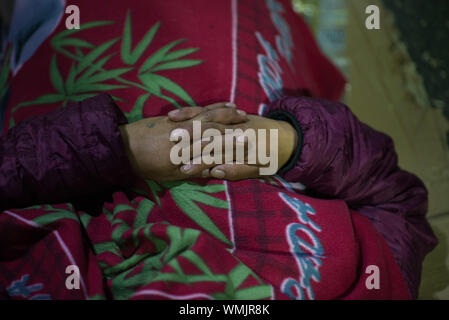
[17,182,272,299]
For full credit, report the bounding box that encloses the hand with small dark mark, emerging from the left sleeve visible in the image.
[120,103,247,181]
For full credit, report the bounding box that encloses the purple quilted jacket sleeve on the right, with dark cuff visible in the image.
[267,97,437,298]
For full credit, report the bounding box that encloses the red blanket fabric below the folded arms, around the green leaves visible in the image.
[0,180,410,299]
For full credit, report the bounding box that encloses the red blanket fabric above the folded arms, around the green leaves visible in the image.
[4,0,345,132]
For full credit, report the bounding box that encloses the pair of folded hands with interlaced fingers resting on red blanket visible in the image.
[120,102,297,181]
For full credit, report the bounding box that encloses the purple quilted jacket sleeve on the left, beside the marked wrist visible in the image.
[0,94,134,210]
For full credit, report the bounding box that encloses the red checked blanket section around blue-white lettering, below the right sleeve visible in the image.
[229,181,410,299]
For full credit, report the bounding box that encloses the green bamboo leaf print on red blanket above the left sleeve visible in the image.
[10,11,203,127]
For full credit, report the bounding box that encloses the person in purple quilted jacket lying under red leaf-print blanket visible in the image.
[0,0,437,300]
